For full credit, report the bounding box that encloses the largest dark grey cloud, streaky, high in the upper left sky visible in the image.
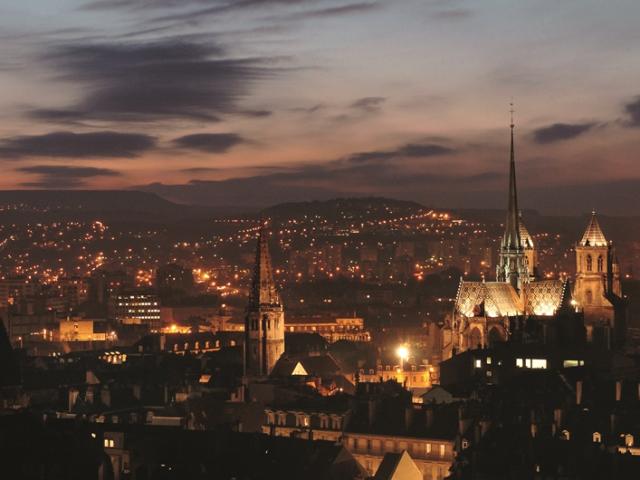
[33,39,275,121]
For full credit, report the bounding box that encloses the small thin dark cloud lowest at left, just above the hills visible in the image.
[16,165,120,189]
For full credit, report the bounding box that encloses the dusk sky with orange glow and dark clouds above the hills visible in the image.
[0,0,640,214]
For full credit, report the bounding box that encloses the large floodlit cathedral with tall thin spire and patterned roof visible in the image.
[443,115,625,359]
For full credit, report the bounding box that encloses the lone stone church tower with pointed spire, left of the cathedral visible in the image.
[245,229,284,376]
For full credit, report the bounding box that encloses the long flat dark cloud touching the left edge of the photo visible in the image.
[0,131,156,158]
